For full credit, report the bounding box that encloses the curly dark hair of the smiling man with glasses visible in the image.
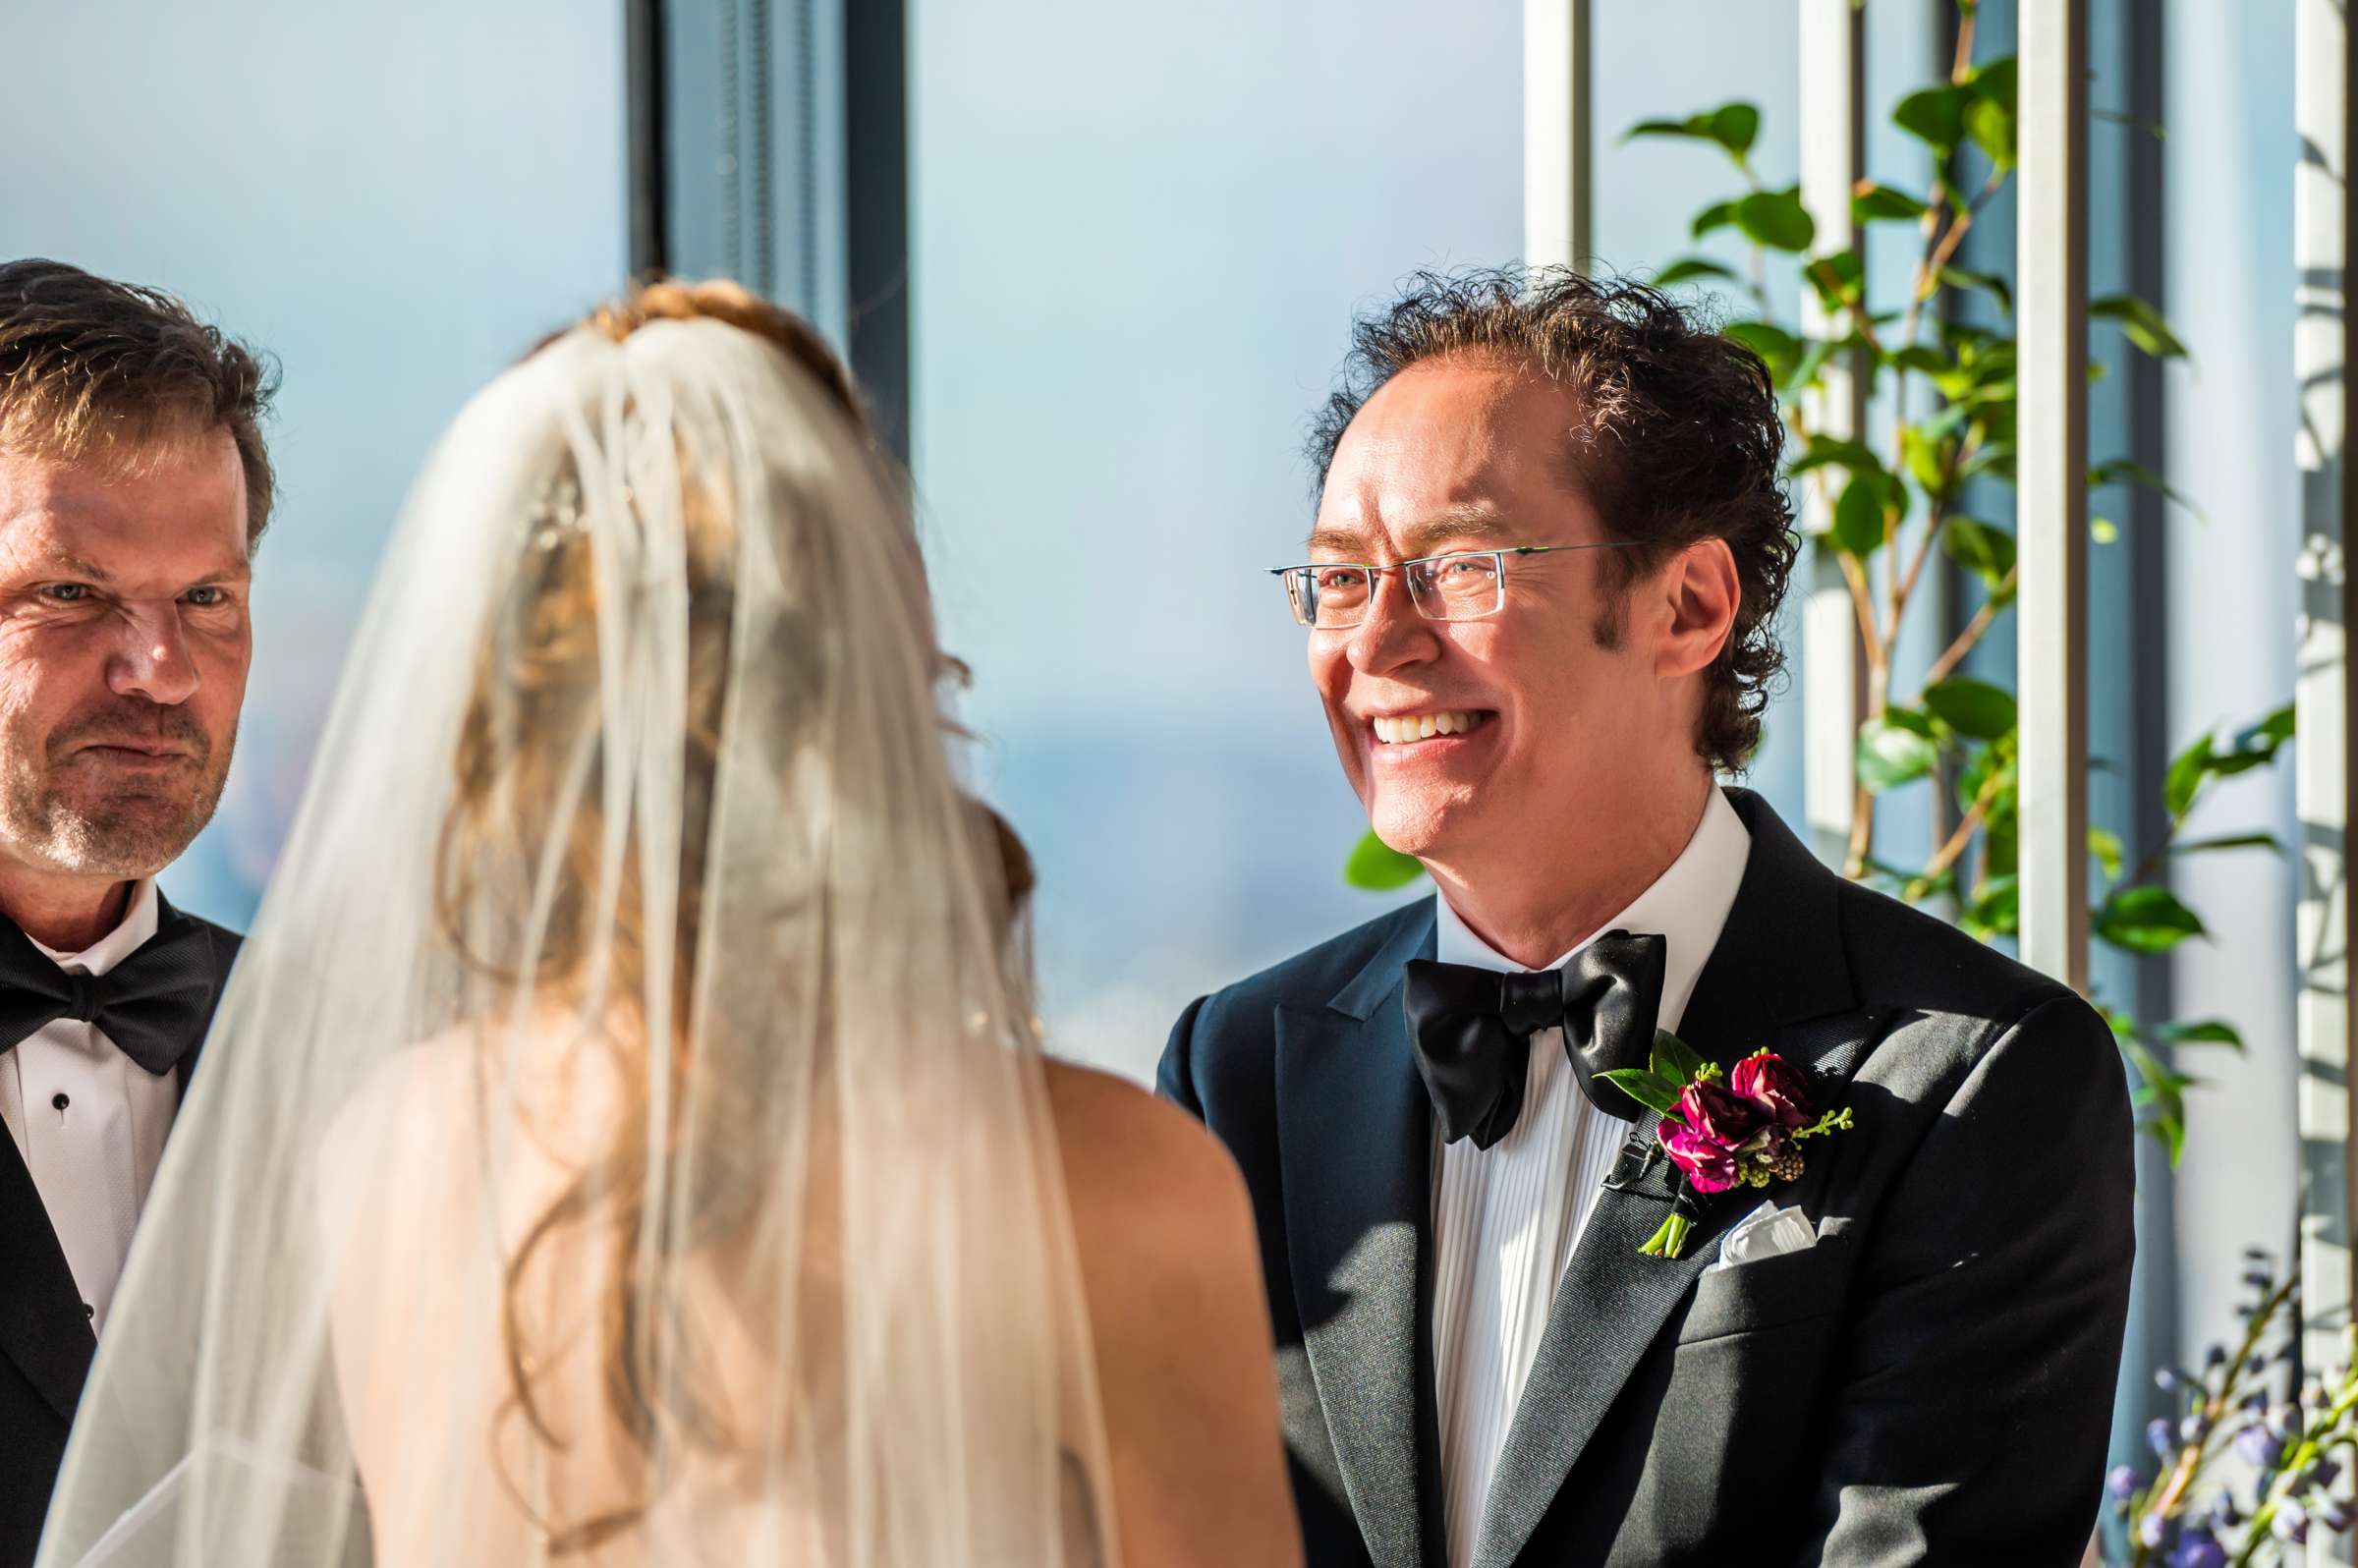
[1309,266,1802,773]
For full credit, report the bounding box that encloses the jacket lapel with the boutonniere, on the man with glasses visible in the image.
[1474,790,1877,1568]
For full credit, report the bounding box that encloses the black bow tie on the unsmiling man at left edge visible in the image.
[0,910,219,1078]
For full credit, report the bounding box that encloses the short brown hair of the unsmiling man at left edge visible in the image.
[0,257,278,549]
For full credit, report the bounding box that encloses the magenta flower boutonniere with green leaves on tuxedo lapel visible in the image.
[1599,1031,1851,1257]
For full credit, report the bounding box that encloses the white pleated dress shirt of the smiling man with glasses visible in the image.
[1433,790,1752,1568]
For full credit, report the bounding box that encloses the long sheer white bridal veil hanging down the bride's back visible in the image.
[40,299,1110,1568]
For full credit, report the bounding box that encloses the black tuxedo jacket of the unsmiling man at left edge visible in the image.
[0,894,238,1568]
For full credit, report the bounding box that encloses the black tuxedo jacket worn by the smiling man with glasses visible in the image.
[1160,790,2134,1568]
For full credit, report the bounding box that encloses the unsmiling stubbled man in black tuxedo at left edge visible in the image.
[0,261,271,1568]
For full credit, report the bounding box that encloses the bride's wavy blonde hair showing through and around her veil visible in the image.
[434,281,1033,1554]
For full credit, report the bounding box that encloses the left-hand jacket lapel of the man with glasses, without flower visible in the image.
[1275,900,1440,1568]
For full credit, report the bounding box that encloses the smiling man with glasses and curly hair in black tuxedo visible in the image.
[1160,271,2132,1568]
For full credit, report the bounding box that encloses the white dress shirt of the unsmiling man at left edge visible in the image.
[0,882,179,1332]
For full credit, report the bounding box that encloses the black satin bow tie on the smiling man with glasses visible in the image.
[1403,931,1667,1148]
